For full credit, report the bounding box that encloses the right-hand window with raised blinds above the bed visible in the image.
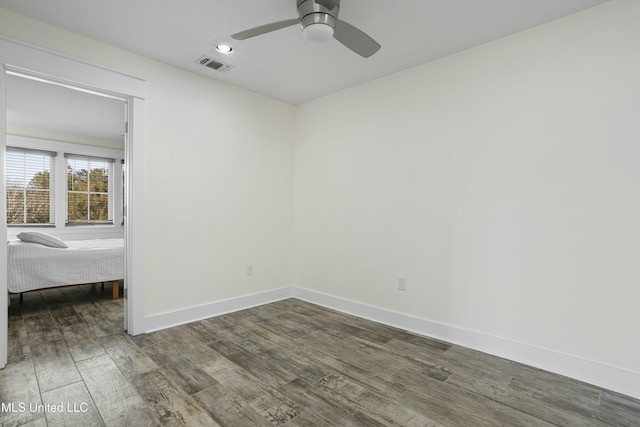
[65,154,114,225]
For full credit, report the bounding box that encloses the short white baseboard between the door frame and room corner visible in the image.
[144,287,293,332]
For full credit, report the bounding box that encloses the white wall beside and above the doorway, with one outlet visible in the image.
[0,9,294,317]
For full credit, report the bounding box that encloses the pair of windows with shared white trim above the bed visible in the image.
[5,135,124,234]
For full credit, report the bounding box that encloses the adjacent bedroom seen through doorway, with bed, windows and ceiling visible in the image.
[6,73,126,312]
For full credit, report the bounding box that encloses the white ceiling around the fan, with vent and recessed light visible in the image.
[0,0,606,104]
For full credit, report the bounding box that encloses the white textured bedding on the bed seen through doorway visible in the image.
[7,239,124,293]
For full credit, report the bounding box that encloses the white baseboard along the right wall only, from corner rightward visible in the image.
[293,287,640,399]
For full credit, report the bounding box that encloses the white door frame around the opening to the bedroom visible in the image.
[0,36,147,368]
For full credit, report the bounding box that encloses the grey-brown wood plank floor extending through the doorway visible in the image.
[0,285,640,427]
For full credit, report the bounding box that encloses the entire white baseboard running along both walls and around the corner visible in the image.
[145,287,640,399]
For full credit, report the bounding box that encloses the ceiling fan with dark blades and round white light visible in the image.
[231,0,380,58]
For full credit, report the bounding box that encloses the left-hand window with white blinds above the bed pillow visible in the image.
[6,147,56,225]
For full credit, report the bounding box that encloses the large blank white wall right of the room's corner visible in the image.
[294,1,640,396]
